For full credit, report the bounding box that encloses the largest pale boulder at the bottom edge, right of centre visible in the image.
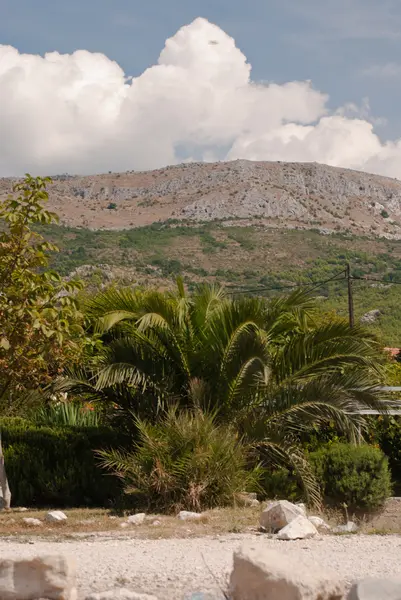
[229,546,344,600]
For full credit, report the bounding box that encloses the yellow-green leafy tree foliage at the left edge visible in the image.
[0,175,88,414]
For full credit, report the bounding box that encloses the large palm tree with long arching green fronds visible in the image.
[59,281,385,501]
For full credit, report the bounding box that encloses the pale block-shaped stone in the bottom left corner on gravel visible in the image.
[0,556,77,600]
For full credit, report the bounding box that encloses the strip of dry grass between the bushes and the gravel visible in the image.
[0,500,401,539]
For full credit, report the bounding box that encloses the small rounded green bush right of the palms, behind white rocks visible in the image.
[309,444,391,510]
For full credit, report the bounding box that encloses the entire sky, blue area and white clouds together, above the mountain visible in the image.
[0,0,401,178]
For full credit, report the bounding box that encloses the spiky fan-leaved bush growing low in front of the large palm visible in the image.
[99,409,263,511]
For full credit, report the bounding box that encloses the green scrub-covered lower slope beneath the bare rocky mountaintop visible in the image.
[38,223,401,346]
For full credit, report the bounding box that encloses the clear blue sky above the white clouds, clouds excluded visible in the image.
[0,0,401,136]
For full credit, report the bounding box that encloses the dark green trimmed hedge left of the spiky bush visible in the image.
[0,418,126,507]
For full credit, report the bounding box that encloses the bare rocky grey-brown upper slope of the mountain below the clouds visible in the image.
[0,160,401,239]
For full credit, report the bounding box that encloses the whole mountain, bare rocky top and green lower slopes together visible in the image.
[0,160,401,347]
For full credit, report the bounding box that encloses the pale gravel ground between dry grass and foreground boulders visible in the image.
[0,535,401,600]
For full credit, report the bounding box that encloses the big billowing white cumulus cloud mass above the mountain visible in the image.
[0,18,401,177]
